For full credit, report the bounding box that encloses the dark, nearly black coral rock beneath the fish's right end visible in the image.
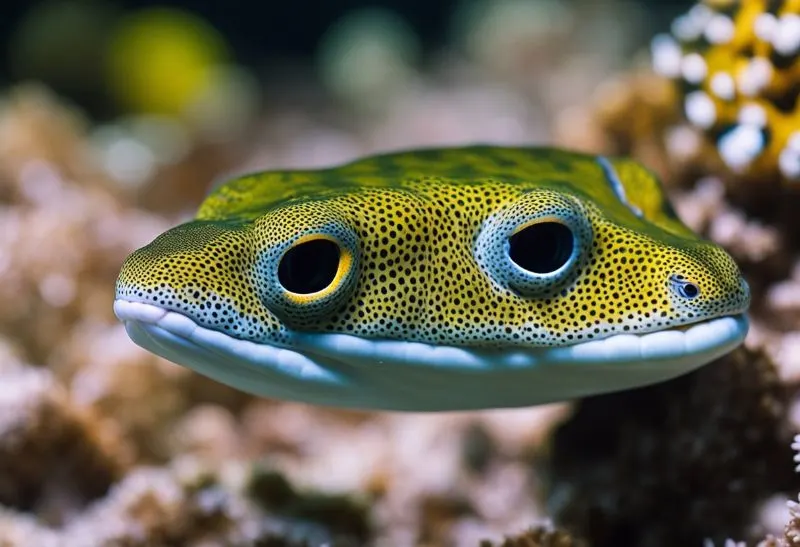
[544,349,800,547]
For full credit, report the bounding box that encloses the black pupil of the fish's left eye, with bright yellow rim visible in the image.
[278,239,339,294]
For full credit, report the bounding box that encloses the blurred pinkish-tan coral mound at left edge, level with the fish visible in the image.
[0,88,173,363]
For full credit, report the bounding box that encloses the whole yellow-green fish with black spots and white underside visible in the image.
[114,146,750,411]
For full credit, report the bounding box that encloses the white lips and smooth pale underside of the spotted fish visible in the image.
[114,299,748,411]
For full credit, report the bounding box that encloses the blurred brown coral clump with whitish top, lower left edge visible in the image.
[0,367,127,524]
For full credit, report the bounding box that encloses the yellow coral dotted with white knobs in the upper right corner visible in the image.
[652,0,800,183]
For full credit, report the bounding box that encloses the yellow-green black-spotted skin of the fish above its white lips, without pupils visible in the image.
[116,146,749,356]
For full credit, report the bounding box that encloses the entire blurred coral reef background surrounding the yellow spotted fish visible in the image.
[0,0,800,547]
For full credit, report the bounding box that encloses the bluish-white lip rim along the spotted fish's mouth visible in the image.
[114,299,748,376]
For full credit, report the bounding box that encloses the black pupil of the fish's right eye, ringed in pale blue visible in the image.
[508,222,575,274]
